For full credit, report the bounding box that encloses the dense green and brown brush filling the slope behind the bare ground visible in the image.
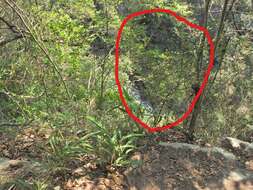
[0,0,253,189]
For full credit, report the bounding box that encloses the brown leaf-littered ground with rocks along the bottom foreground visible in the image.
[0,129,253,190]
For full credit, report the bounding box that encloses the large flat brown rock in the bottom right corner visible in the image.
[125,143,253,190]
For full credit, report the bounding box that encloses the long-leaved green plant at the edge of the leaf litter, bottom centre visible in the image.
[87,116,143,166]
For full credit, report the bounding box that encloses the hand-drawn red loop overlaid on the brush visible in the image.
[115,8,214,132]
